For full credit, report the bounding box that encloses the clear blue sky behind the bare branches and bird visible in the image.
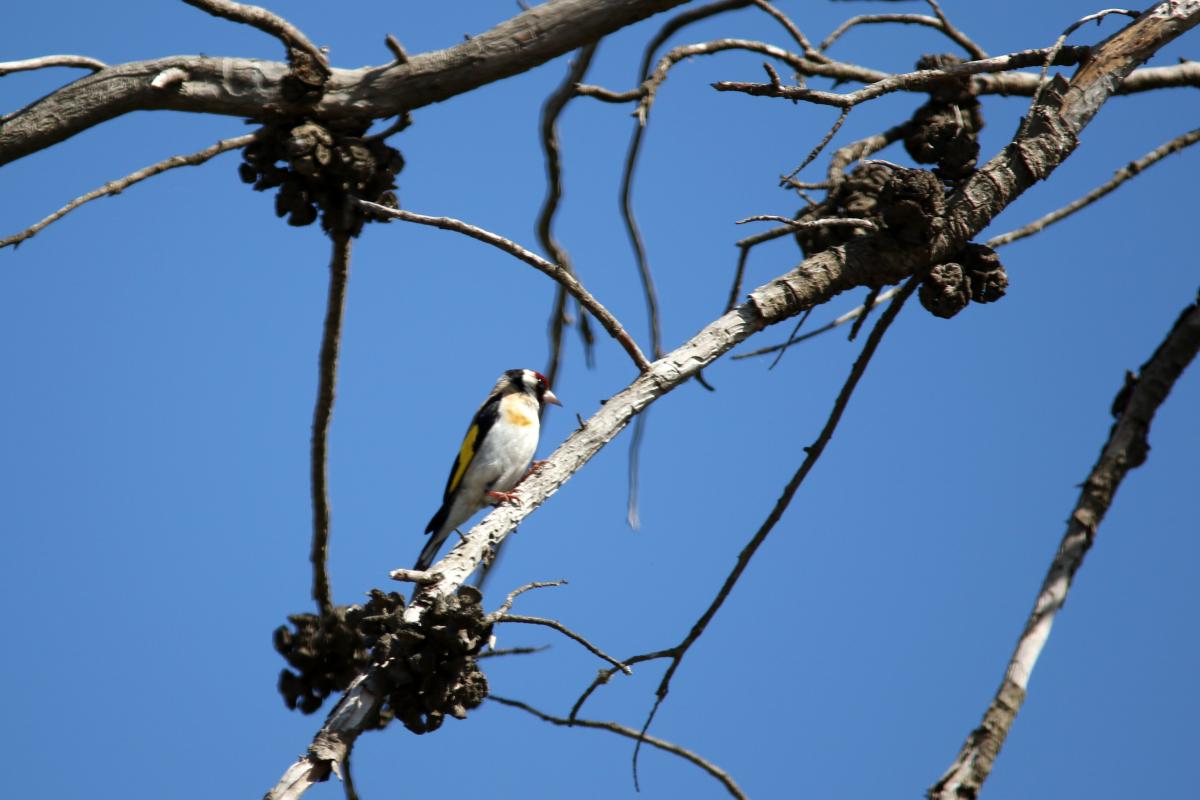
[0,0,1200,800]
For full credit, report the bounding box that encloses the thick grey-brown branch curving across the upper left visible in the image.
[0,0,684,164]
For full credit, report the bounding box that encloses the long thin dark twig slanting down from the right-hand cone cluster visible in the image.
[632,277,928,784]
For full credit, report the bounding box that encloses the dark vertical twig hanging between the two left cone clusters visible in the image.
[308,233,350,616]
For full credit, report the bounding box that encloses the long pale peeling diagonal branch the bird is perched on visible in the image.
[269,1,1200,799]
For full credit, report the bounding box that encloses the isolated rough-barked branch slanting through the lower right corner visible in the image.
[928,292,1200,800]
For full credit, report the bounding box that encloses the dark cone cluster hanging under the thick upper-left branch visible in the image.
[239,120,404,236]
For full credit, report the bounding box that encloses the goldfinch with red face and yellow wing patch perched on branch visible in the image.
[413,369,562,571]
